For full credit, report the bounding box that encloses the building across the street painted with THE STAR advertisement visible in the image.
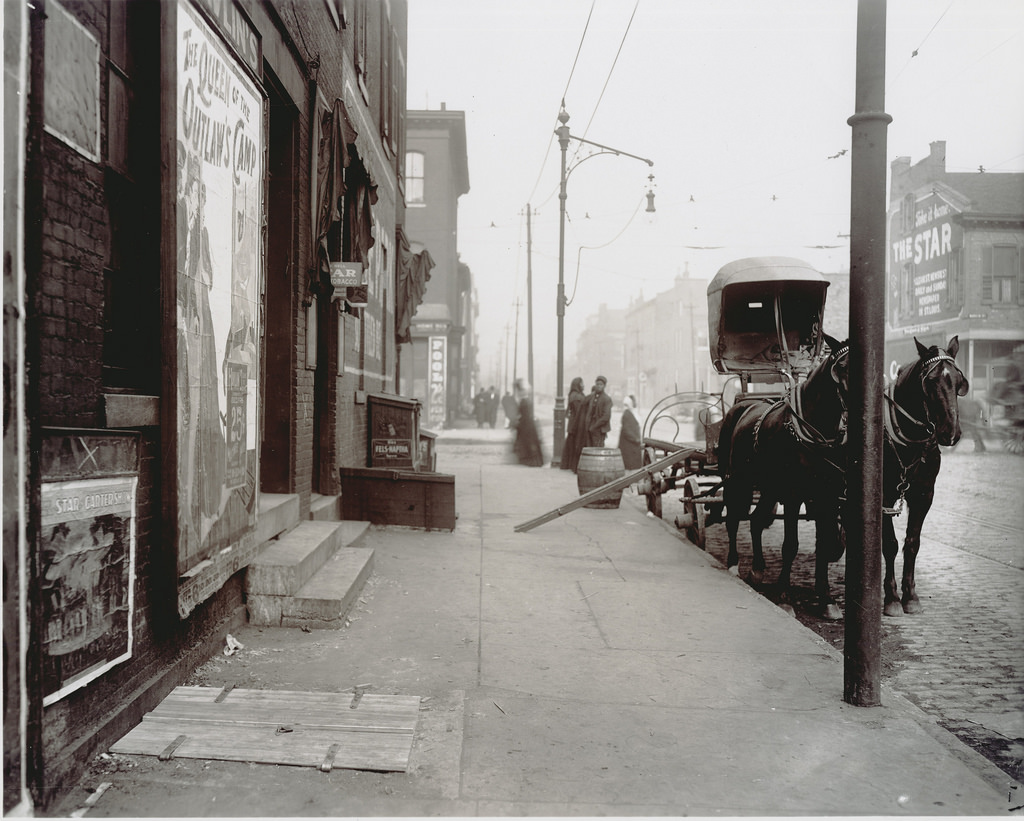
[886,140,1024,398]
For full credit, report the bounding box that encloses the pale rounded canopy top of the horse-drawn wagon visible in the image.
[708,257,828,376]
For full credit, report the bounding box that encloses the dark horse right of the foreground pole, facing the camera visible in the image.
[882,337,970,616]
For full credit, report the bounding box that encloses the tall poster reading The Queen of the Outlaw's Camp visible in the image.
[175,2,264,589]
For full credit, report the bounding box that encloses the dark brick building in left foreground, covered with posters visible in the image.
[3,0,428,813]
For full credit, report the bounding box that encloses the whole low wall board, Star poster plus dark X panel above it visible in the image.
[40,428,138,705]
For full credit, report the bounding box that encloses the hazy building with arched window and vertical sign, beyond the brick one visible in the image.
[398,102,476,428]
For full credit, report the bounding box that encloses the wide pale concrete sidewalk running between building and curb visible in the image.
[57,430,1024,817]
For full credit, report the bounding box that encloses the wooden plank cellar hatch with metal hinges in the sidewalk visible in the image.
[111,687,420,772]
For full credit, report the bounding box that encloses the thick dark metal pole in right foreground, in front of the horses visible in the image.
[843,0,892,707]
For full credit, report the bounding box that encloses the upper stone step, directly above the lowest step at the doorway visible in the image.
[246,520,369,596]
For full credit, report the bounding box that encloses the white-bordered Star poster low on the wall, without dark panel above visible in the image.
[40,476,138,705]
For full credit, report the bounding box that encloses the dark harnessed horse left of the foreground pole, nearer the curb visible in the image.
[718,336,850,620]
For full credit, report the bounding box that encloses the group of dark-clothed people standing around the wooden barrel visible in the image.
[559,377,641,472]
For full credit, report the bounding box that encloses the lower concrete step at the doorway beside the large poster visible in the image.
[281,548,374,630]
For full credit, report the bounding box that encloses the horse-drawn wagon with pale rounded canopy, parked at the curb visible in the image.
[637,257,828,548]
